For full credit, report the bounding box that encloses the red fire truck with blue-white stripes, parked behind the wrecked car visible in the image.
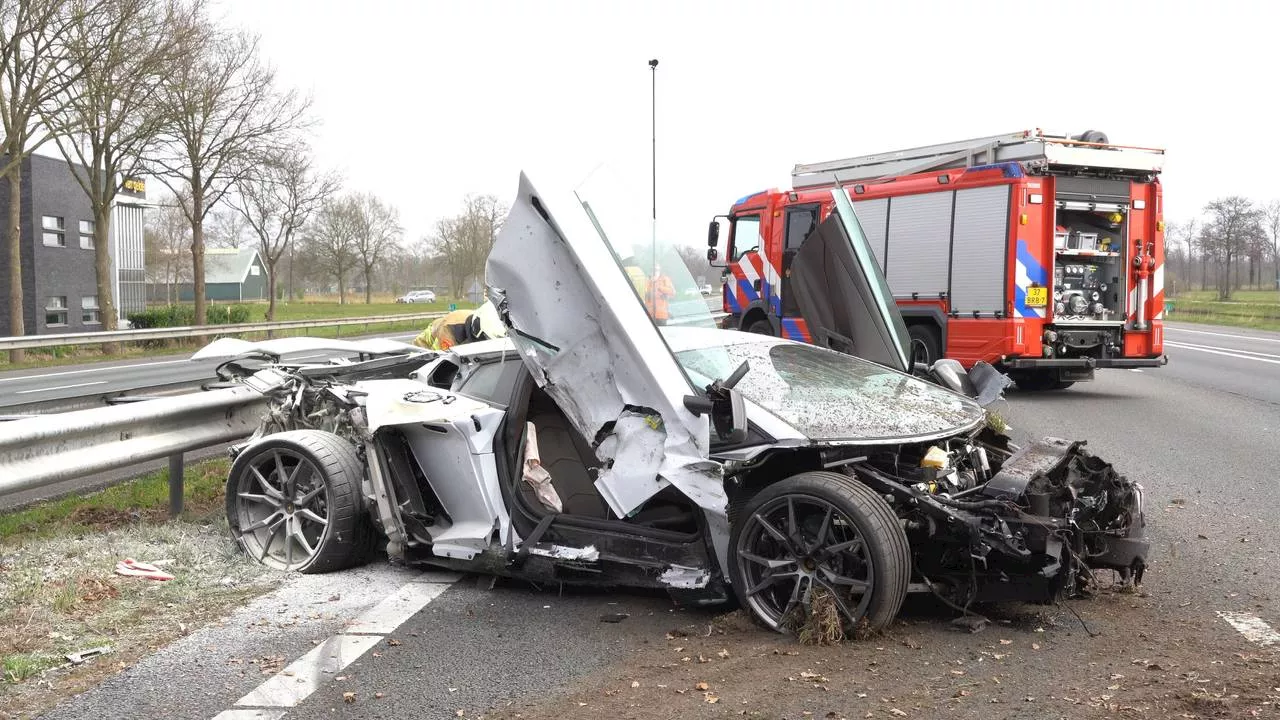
[708,131,1166,389]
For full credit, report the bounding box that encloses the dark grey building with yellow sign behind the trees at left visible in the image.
[0,155,146,337]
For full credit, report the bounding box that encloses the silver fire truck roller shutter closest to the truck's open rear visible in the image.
[951,184,1010,314]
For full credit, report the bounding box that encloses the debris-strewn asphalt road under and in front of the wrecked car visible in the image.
[35,319,1280,720]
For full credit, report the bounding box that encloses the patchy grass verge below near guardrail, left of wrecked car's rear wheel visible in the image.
[0,460,279,717]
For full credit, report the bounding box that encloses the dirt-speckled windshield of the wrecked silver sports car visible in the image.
[672,332,983,441]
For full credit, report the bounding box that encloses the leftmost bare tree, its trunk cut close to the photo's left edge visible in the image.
[0,0,78,363]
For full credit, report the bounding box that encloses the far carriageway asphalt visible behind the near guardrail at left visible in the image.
[0,333,413,413]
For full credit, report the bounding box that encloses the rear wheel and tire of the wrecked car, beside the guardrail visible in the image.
[227,430,378,573]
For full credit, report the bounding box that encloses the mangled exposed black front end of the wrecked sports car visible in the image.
[842,432,1148,606]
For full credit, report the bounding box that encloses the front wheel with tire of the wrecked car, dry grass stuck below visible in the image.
[728,471,911,632]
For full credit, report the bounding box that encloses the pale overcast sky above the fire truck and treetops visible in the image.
[192,0,1280,245]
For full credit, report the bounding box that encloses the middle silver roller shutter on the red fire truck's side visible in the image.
[884,191,954,297]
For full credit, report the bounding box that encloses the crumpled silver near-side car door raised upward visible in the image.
[485,173,726,518]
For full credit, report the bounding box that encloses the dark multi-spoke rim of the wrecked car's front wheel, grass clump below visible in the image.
[736,495,874,629]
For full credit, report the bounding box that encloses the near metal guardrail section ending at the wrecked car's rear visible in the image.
[0,387,266,514]
